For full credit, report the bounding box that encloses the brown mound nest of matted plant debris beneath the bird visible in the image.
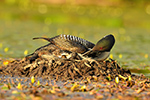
[0,44,131,80]
